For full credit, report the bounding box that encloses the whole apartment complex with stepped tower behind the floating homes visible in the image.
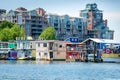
[6,3,114,42]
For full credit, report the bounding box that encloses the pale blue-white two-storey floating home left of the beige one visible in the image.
[16,38,36,60]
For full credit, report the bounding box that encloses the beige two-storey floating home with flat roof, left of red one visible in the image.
[36,40,66,60]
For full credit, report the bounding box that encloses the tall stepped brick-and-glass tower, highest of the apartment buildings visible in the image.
[80,3,114,39]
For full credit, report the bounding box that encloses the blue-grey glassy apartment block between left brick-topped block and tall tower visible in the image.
[47,14,85,41]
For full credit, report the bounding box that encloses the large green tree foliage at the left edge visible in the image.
[0,21,25,41]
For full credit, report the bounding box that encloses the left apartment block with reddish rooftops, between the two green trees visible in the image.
[6,7,46,39]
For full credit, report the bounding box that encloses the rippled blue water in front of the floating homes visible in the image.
[0,60,120,80]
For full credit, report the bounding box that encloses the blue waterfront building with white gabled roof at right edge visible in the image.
[81,38,120,59]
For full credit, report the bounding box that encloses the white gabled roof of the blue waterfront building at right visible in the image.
[81,38,120,44]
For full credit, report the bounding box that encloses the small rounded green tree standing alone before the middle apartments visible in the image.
[39,26,56,40]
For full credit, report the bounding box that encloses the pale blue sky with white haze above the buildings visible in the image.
[0,0,120,41]
